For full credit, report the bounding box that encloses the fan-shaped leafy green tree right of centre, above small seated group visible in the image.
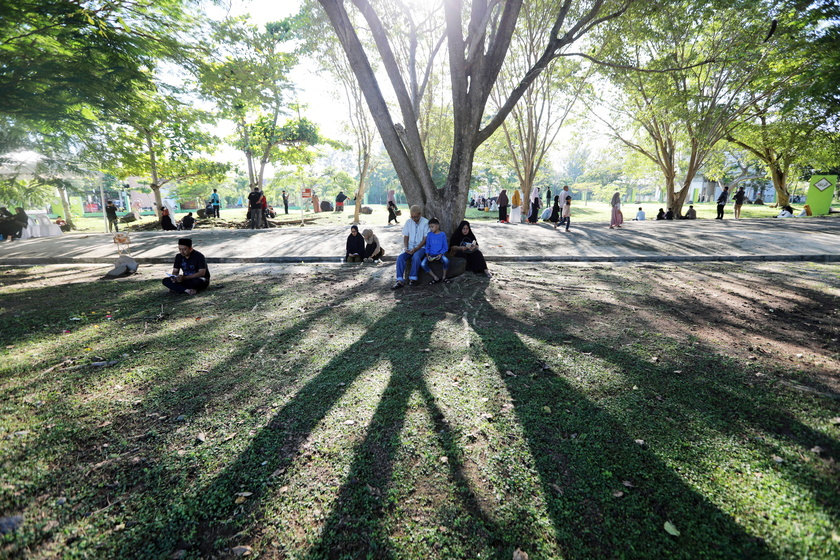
[601,0,798,216]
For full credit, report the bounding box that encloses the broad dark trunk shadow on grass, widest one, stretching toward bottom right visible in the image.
[452,282,773,558]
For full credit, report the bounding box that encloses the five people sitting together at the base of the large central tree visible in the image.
[344,205,491,290]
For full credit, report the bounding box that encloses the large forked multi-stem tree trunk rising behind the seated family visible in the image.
[318,0,632,234]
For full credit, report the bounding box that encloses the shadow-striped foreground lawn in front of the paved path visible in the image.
[0,264,840,560]
